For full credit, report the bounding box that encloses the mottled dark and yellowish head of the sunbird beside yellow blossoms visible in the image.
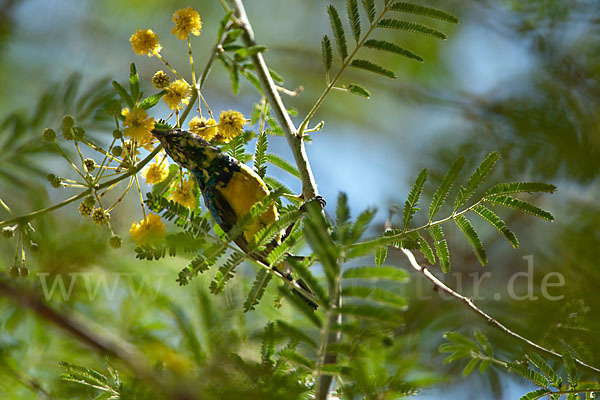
[152,129,221,171]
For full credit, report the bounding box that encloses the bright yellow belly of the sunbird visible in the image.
[217,164,278,241]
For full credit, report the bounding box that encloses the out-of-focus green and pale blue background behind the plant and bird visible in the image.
[0,0,600,399]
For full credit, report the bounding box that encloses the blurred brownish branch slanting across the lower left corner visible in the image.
[0,274,201,400]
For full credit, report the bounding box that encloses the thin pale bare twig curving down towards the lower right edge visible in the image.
[385,217,600,376]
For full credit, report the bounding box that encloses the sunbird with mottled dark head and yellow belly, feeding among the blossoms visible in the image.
[152,129,324,309]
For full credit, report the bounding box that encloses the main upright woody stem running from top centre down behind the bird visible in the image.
[231,0,342,400]
